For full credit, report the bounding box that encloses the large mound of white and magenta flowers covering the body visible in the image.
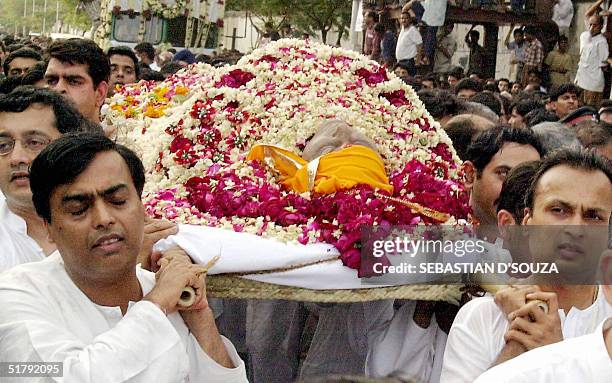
[107,39,468,268]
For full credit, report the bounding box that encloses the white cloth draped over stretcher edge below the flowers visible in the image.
[154,225,392,290]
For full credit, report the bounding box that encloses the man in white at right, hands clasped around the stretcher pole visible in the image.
[441,149,612,382]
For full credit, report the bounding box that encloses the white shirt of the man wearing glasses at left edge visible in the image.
[0,196,46,273]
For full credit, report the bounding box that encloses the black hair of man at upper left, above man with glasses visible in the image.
[47,38,110,88]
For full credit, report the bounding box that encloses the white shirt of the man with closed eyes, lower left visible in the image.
[0,253,247,383]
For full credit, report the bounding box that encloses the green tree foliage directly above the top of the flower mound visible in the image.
[227,0,351,44]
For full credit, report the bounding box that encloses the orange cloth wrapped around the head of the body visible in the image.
[247,145,393,194]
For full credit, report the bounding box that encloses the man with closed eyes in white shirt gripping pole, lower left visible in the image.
[0,133,247,383]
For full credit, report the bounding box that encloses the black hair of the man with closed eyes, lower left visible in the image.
[30,133,145,223]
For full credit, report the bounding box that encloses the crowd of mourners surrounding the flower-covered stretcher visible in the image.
[0,1,612,383]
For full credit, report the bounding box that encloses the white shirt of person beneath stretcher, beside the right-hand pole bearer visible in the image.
[366,301,446,383]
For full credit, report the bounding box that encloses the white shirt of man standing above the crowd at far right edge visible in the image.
[576,31,608,92]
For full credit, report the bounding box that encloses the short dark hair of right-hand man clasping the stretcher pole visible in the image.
[525,149,612,209]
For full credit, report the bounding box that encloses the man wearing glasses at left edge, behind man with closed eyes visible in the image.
[0,87,102,271]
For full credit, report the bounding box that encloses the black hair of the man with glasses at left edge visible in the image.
[0,85,103,134]
